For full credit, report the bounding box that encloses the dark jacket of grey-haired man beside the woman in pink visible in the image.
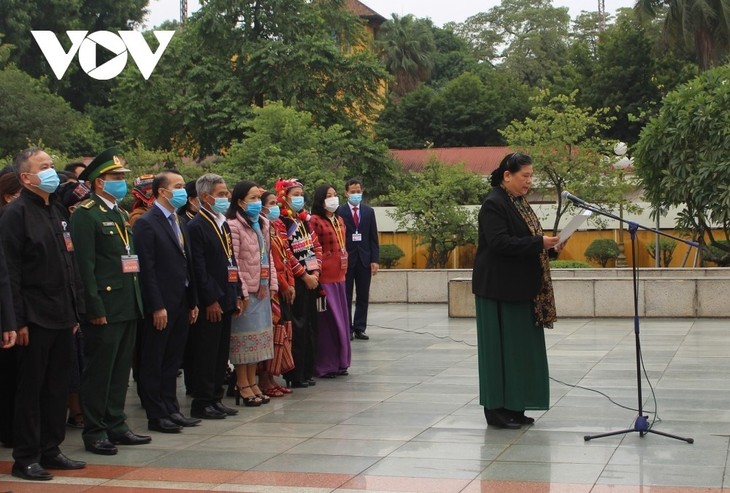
[188,210,243,312]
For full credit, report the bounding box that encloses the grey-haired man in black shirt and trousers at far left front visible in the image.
[0,148,86,480]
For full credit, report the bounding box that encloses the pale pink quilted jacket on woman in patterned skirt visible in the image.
[228,214,279,297]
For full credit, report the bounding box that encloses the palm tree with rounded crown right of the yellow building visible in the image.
[375,14,436,96]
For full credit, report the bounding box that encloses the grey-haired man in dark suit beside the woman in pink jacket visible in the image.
[188,173,243,419]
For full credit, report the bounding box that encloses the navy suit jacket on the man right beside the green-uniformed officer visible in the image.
[134,204,198,314]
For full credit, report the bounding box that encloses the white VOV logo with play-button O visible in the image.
[31,31,175,80]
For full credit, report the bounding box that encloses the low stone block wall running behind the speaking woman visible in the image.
[370,268,730,317]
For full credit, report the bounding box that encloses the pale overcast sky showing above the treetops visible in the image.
[147,0,636,27]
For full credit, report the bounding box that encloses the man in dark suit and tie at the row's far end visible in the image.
[337,179,380,341]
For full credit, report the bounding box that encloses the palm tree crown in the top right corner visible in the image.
[636,0,730,71]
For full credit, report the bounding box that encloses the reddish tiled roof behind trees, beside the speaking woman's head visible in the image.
[390,146,511,176]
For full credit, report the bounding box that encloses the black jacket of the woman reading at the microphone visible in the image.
[472,187,543,301]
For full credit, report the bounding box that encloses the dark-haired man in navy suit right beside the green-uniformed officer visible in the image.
[134,170,200,433]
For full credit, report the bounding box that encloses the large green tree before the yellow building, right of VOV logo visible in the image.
[189,0,387,129]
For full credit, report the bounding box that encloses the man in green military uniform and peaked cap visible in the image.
[71,148,151,455]
